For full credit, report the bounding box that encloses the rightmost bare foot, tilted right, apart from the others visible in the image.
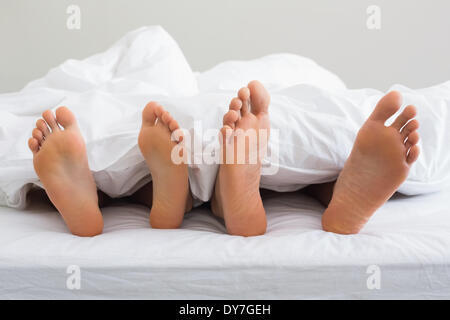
[322,91,419,234]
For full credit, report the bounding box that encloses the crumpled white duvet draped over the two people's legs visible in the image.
[0,27,450,207]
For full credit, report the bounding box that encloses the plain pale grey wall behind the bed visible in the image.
[0,0,450,93]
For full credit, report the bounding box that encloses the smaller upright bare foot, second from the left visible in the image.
[139,102,192,229]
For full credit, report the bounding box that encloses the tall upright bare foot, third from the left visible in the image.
[211,81,270,236]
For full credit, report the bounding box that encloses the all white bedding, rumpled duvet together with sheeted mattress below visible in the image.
[0,27,450,299]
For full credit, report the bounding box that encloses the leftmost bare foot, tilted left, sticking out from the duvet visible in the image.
[28,107,103,237]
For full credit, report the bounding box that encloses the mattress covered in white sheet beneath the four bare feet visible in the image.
[0,190,450,299]
